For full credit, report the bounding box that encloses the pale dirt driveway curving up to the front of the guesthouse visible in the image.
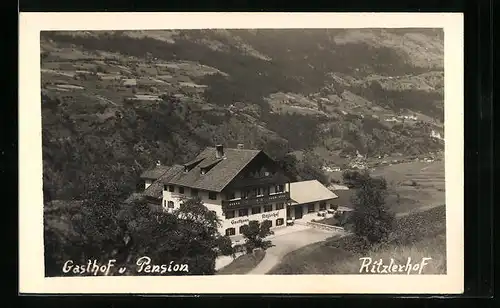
[248,228,336,275]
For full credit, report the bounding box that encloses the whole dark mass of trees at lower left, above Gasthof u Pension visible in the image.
[44,172,224,276]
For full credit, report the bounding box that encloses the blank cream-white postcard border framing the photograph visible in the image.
[19,13,464,294]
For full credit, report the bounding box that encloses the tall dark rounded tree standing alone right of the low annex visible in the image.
[351,172,394,244]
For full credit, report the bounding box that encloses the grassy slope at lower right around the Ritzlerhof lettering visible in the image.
[270,205,446,275]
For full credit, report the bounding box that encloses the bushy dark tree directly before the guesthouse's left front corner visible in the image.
[116,198,219,275]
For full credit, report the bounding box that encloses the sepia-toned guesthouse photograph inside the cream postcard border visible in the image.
[19,14,463,293]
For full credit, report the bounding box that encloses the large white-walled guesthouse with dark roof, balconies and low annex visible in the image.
[141,145,336,239]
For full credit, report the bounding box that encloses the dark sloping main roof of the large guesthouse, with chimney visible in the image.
[167,147,263,192]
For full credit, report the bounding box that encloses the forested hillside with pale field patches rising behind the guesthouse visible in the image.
[41,29,444,199]
